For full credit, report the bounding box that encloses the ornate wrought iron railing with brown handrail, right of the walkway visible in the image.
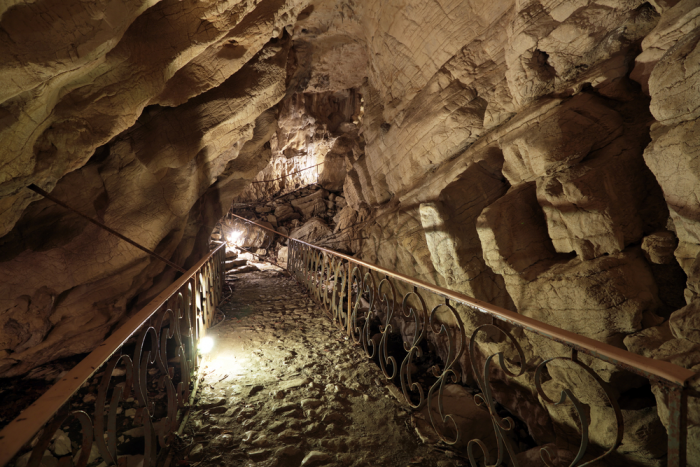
[235,216,698,467]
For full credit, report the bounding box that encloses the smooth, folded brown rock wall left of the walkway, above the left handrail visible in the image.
[0,0,307,376]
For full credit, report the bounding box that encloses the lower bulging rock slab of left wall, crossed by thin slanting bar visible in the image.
[0,36,288,375]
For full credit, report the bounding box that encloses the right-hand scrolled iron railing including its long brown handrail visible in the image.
[226,215,695,467]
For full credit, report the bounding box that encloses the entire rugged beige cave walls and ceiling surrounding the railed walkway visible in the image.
[0,0,700,464]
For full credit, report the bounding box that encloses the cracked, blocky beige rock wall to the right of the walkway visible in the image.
[238,1,700,465]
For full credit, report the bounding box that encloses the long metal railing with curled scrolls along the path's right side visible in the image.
[215,214,697,467]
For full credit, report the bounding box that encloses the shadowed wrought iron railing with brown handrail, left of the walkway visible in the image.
[0,246,225,467]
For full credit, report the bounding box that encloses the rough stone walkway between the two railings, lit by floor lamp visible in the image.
[178,271,452,467]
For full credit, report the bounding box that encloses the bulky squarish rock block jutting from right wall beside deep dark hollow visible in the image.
[537,139,666,260]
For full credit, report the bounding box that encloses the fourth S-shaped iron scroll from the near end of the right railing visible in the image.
[399,287,428,409]
